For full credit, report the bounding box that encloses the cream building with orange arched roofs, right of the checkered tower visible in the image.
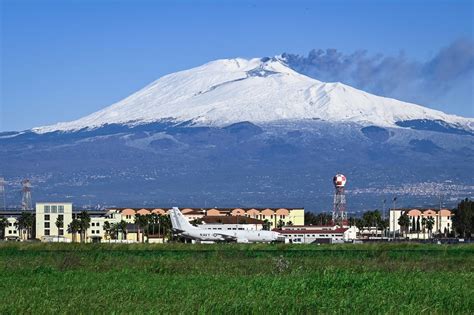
[389,209,453,239]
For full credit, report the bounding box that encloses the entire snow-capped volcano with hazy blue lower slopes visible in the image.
[0,57,474,211]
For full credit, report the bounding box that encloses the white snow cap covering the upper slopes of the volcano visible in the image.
[33,57,474,133]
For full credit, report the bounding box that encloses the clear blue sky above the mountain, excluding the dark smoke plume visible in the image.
[0,0,474,131]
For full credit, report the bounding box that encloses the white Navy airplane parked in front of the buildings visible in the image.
[169,207,285,243]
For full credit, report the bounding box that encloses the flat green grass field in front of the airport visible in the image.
[0,243,474,314]
